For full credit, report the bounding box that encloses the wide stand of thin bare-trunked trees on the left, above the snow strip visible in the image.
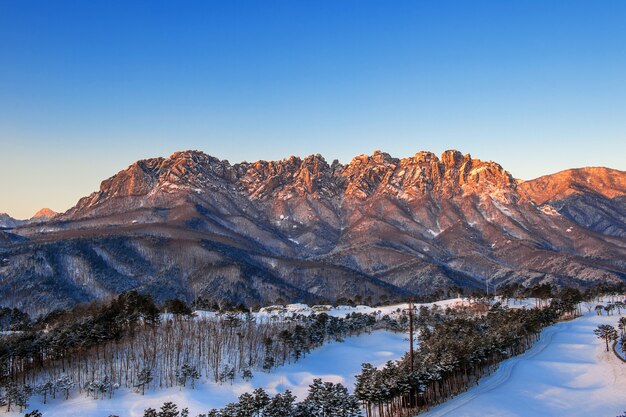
[0,291,406,410]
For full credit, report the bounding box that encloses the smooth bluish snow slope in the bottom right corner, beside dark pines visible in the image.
[420,312,626,417]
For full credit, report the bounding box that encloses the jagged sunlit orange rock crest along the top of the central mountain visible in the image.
[64,150,532,214]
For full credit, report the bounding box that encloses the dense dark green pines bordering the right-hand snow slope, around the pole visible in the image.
[355,294,579,417]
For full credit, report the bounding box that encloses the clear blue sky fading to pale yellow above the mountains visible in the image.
[0,0,626,218]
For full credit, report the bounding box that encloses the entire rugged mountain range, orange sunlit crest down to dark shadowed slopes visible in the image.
[0,151,626,316]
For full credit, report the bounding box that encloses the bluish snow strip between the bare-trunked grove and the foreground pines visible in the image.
[6,331,409,417]
